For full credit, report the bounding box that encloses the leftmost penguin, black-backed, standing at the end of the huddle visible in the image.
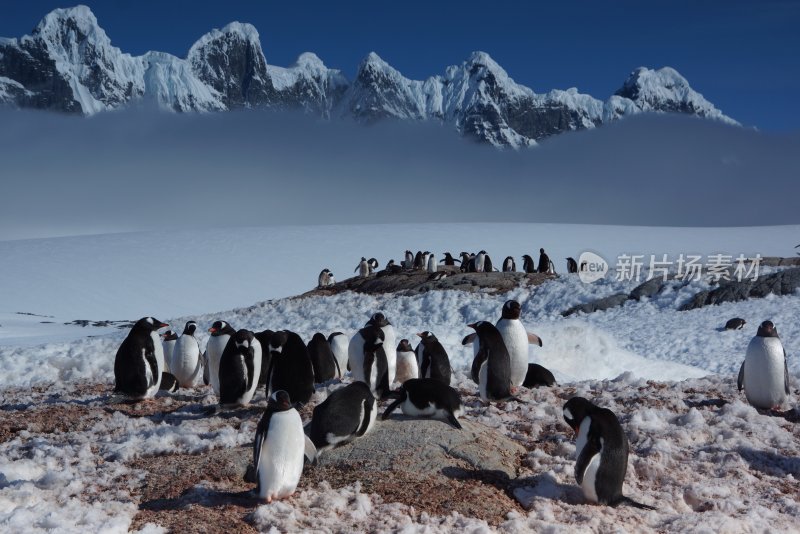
[114,317,169,400]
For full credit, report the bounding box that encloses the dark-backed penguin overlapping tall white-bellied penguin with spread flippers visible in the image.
[467,321,512,401]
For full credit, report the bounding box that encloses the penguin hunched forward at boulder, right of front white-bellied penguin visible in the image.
[308,382,378,453]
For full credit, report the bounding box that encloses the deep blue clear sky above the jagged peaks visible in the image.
[0,0,800,132]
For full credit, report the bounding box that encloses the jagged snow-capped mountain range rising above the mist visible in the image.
[0,6,738,148]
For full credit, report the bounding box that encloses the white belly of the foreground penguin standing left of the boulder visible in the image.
[257,409,305,501]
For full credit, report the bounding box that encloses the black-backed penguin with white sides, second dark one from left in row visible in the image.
[219,328,261,406]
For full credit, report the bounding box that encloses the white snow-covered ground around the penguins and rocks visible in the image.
[0,224,800,532]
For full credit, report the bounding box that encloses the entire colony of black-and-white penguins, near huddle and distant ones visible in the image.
[114,276,790,510]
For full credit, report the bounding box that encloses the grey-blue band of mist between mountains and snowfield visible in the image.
[0,108,800,240]
